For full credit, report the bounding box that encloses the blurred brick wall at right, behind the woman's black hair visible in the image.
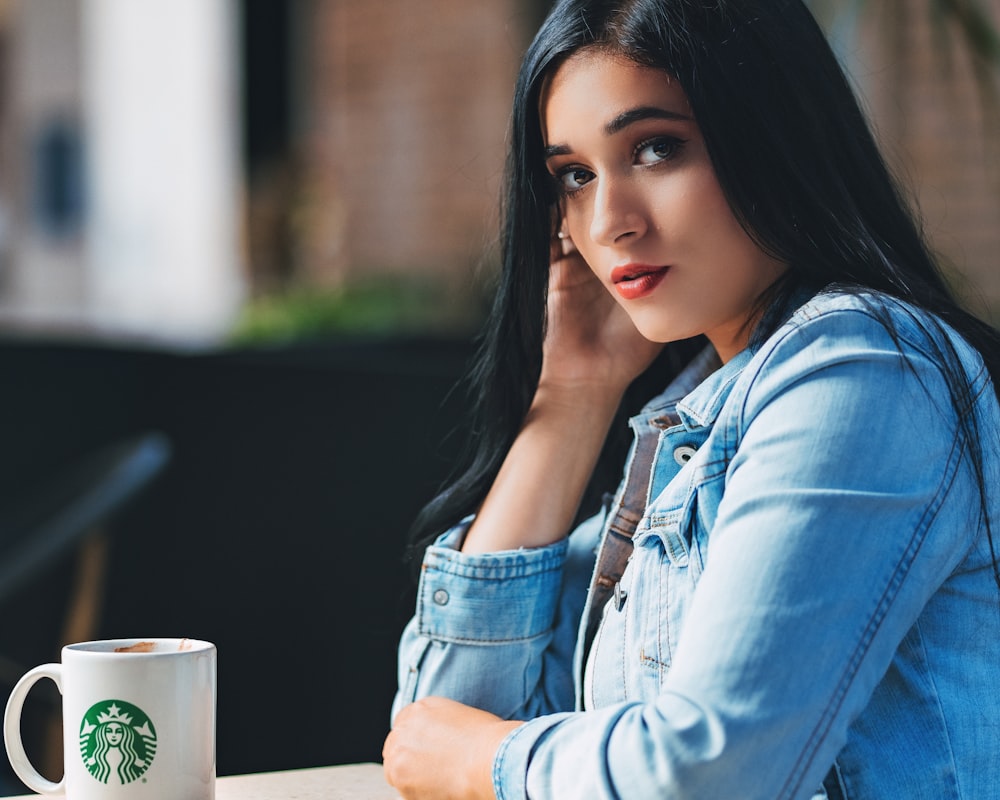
[852,0,1000,323]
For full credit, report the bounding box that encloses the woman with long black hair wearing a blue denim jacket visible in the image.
[384,0,1000,800]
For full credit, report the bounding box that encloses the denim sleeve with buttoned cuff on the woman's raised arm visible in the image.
[392,518,601,719]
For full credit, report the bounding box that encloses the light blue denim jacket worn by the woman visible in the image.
[394,293,1000,800]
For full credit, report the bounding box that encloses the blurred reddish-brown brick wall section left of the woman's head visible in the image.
[300,0,529,294]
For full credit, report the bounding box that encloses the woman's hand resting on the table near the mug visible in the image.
[382,697,521,800]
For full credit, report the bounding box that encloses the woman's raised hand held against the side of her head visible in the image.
[540,228,663,395]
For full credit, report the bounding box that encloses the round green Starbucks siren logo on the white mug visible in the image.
[80,700,156,784]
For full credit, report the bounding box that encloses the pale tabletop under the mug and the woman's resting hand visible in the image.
[8,764,399,800]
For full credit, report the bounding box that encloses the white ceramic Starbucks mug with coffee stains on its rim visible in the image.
[3,639,216,800]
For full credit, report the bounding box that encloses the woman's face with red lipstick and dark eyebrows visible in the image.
[540,50,785,360]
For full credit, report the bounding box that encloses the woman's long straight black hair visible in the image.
[406,0,1000,585]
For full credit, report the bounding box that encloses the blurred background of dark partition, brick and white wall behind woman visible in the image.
[0,0,1000,793]
